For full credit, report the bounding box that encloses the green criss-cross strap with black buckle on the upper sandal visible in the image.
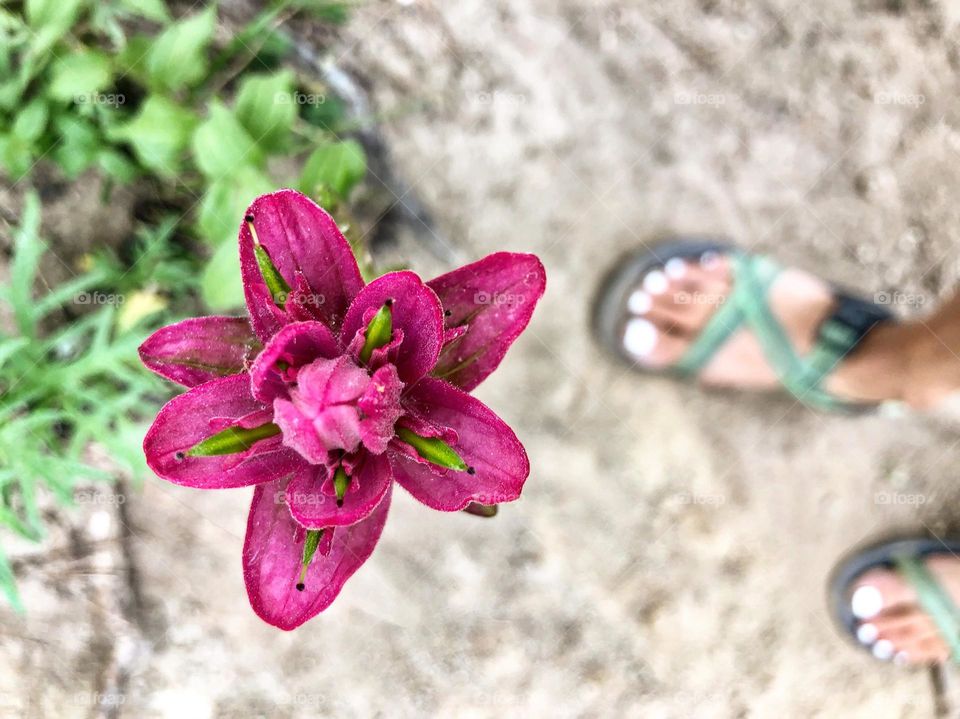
[674,252,889,410]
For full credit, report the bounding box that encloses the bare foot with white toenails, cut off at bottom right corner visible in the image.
[850,553,960,665]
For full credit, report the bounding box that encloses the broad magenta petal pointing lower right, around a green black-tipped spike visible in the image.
[388,378,530,512]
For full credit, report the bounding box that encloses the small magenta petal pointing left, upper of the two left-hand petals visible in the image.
[140,317,260,387]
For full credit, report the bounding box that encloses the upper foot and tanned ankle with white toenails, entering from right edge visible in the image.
[596,241,960,407]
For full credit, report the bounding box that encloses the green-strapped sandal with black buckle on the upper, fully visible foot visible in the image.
[592,238,894,411]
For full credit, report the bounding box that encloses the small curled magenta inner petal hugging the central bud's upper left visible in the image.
[250,322,340,402]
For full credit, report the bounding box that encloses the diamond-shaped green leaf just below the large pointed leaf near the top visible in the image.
[109,95,197,177]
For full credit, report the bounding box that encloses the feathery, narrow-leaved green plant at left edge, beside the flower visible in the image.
[0,194,169,607]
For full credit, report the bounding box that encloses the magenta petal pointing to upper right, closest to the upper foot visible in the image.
[427,252,547,391]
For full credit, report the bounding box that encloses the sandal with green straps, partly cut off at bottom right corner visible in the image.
[828,537,960,664]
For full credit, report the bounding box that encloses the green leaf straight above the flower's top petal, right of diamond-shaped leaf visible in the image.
[234,70,297,152]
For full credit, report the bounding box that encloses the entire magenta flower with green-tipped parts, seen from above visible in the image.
[140,190,546,630]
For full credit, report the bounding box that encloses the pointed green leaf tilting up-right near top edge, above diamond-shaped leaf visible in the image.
[145,5,217,90]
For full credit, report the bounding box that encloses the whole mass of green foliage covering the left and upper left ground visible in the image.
[0,0,374,606]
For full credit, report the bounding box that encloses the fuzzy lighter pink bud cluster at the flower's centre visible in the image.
[274,356,403,464]
